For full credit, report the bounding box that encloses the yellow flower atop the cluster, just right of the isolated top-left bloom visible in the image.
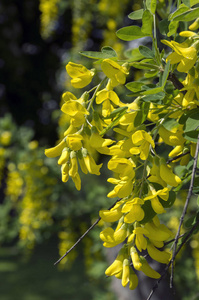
[101,58,129,87]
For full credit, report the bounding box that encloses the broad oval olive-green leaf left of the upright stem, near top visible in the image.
[116,26,149,41]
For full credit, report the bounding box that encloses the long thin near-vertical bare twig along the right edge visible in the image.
[170,135,199,288]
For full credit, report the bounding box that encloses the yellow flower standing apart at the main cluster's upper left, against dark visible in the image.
[66,62,94,89]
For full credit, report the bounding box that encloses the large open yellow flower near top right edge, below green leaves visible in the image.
[161,40,197,73]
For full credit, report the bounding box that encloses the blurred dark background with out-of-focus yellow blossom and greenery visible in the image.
[0,0,199,300]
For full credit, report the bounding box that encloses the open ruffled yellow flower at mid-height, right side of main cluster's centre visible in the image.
[129,130,155,160]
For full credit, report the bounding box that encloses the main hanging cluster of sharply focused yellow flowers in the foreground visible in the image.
[45,58,188,289]
